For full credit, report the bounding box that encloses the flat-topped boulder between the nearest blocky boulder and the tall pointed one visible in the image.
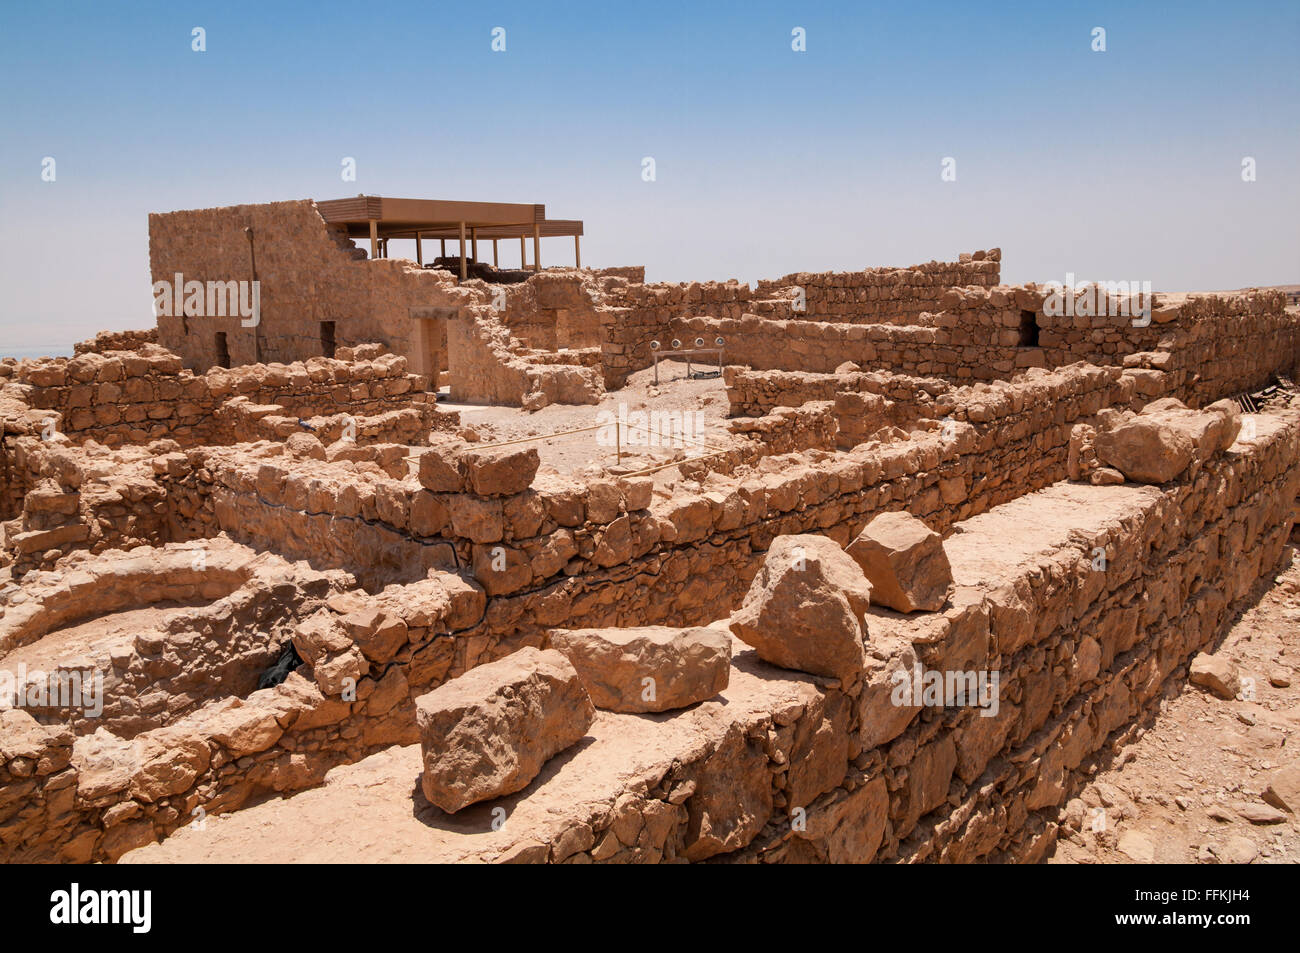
[551,625,731,711]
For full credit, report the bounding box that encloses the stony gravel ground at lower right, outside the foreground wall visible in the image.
[1052,555,1300,863]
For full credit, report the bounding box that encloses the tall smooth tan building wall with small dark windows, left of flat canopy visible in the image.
[150,199,467,371]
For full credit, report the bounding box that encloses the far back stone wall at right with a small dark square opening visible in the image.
[670,289,1300,404]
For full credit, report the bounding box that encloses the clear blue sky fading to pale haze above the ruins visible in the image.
[0,0,1300,354]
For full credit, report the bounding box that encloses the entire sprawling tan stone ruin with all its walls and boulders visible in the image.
[0,203,1300,863]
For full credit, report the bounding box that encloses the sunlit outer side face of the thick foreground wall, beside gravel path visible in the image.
[533,416,1300,863]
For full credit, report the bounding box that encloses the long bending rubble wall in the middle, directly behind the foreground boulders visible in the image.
[188,367,1134,627]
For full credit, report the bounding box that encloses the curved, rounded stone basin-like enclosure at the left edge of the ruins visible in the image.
[0,537,355,738]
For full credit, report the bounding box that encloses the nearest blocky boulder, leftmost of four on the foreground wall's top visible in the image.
[416,647,595,813]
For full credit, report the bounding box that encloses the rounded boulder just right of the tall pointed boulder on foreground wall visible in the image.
[848,512,953,612]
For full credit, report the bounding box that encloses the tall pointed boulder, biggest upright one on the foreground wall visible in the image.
[731,536,871,684]
